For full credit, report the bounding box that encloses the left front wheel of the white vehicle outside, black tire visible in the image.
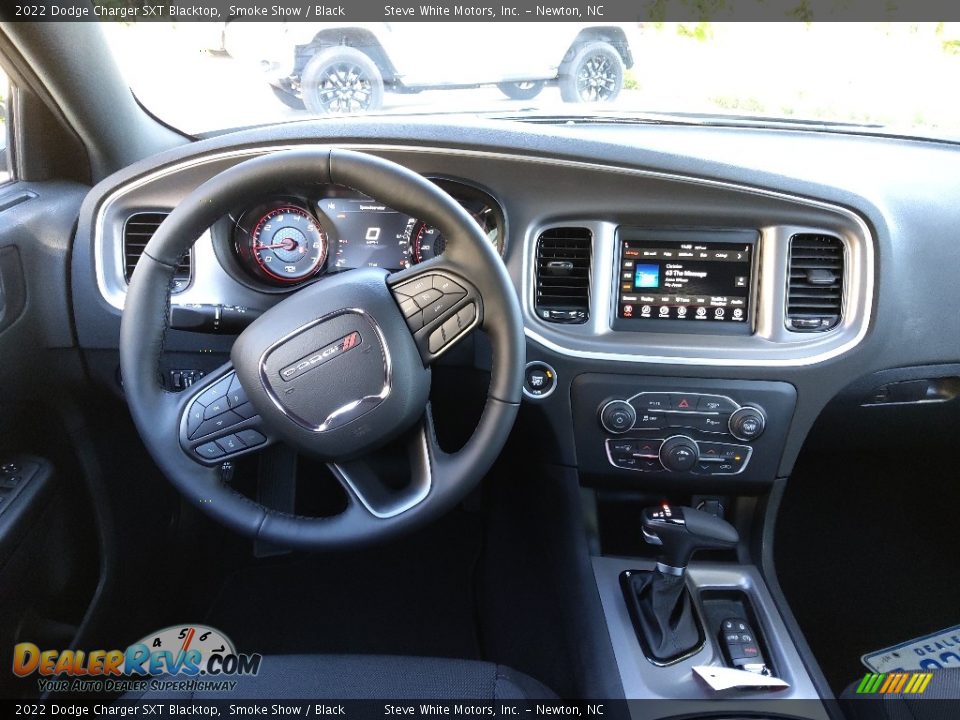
[300,47,383,115]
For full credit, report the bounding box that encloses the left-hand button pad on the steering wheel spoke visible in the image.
[179,363,273,465]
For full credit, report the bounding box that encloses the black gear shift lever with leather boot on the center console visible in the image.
[623,504,739,663]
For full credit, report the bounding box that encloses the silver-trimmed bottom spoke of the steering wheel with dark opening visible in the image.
[328,406,443,519]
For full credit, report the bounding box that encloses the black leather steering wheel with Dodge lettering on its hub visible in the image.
[120,148,525,549]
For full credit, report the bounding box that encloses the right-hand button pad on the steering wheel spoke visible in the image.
[388,257,483,365]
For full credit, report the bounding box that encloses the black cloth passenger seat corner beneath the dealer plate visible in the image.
[840,668,960,720]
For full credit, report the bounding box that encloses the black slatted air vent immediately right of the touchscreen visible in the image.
[787,235,843,332]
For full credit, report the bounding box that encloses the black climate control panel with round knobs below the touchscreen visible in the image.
[573,374,796,485]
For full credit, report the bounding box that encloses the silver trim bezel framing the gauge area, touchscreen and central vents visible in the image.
[93,142,875,367]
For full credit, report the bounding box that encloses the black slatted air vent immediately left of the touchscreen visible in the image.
[535,227,593,323]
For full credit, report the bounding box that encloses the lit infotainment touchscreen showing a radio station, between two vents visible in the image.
[617,229,757,329]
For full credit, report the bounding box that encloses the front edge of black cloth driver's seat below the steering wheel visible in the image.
[123,655,556,700]
